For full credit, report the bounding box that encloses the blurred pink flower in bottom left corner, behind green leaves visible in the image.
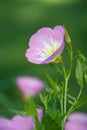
[0,108,43,130]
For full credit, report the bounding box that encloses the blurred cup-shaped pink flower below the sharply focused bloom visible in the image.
[16,76,44,96]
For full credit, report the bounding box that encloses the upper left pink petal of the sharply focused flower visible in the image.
[29,27,53,48]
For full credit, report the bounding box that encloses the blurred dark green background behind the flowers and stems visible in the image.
[0,0,87,116]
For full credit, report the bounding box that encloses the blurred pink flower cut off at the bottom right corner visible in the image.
[65,112,87,130]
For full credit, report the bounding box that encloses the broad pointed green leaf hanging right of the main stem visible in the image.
[75,59,84,88]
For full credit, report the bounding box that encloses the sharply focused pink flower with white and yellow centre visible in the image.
[26,26,65,64]
